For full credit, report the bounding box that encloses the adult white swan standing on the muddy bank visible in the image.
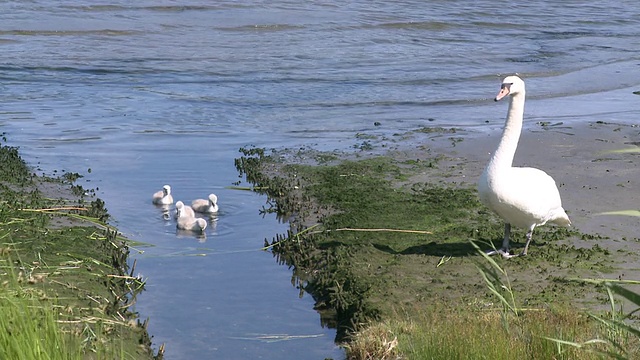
[478,76,571,257]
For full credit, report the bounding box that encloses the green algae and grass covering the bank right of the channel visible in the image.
[236,123,637,359]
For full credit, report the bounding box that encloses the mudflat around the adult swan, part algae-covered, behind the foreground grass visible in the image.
[237,123,639,358]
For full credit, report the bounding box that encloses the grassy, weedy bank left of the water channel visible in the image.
[0,136,162,359]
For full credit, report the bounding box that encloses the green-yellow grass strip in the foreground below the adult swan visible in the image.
[372,304,600,360]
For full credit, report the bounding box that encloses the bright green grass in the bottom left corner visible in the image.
[0,253,139,360]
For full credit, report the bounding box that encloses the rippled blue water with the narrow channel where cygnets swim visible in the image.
[0,0,640,359]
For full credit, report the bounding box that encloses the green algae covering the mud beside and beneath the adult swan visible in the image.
[236,148,615,341]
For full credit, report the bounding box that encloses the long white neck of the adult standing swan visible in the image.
[488,92,525,171]
